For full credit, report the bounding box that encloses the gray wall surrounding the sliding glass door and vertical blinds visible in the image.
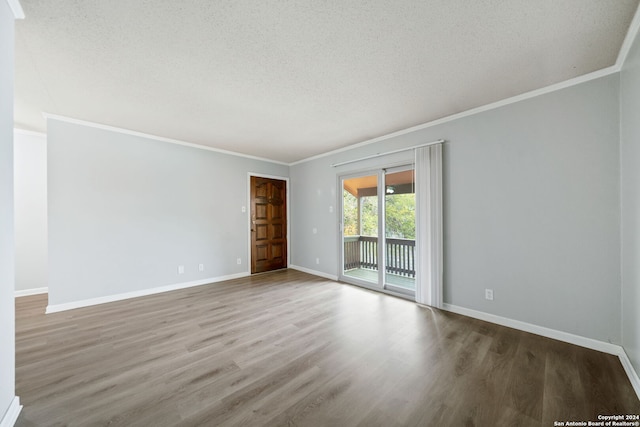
[290,74,621,344]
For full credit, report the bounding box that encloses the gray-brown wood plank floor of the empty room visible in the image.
[16,270,640,427]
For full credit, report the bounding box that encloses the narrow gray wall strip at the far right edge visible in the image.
[620,29,640,373]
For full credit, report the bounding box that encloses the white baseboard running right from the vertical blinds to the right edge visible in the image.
[442,303,640,399]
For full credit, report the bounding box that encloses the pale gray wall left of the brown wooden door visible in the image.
[47,119,288,305]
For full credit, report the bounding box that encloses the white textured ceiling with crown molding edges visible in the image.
[15,0,638,162]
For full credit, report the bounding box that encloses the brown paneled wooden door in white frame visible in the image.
[251,176,287,273]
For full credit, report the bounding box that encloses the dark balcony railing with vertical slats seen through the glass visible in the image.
[344,236,416,277]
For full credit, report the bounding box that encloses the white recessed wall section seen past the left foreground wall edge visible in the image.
[13,130,48,291]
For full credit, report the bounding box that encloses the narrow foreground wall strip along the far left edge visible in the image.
[0,1,15,420]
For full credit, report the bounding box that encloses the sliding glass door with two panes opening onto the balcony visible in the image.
[340,166,416,296]
